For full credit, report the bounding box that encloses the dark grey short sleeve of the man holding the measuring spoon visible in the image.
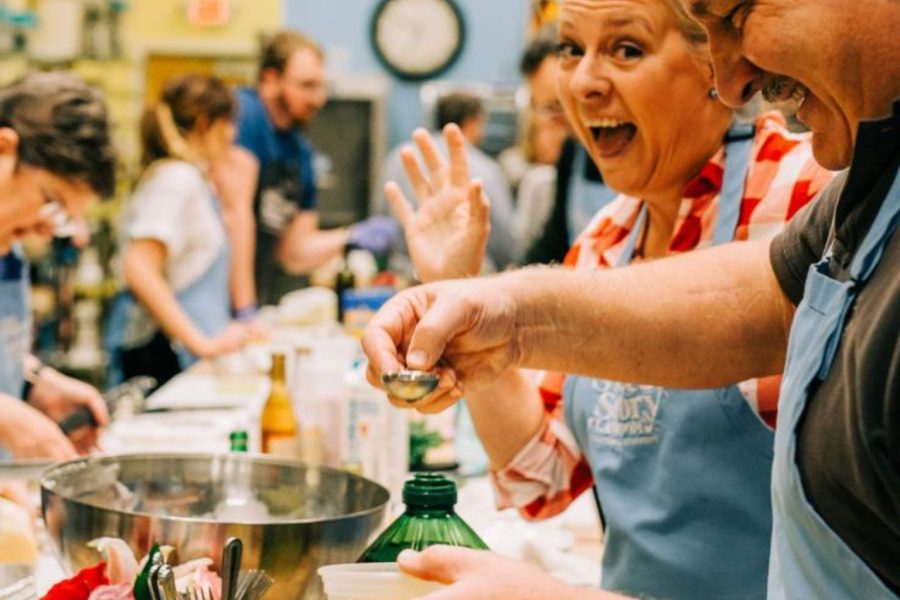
[769,172,847,306]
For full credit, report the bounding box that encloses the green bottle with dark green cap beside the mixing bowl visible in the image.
[357,473,488,563]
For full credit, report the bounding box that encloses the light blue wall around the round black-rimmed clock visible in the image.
[284,0,529,146]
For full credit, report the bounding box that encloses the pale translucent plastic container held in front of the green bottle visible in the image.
[318,563,444,600]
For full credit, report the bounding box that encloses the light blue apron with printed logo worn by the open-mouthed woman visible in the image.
[564,126,774,600]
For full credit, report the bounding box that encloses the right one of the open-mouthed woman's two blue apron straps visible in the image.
[713,123,756,246]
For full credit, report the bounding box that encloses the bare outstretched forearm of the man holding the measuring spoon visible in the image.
[506,242,792,387]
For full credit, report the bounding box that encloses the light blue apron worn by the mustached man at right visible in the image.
[769,166,900,600]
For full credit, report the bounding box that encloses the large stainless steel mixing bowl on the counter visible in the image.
[41,454,389,600]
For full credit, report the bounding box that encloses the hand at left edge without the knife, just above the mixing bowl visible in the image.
[0,394,78,461]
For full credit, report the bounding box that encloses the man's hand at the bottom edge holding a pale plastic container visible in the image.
[397,546,626,600]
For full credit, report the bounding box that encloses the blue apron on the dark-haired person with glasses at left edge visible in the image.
[0,247,31,398]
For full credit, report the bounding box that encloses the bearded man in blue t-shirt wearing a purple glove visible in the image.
[232,31,397,304]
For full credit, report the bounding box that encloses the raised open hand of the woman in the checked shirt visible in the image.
[384,124,491,282]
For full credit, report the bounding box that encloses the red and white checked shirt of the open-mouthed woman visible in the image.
[493,112,833,519]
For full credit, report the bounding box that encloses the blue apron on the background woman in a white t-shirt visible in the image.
[106,188,231,381]
